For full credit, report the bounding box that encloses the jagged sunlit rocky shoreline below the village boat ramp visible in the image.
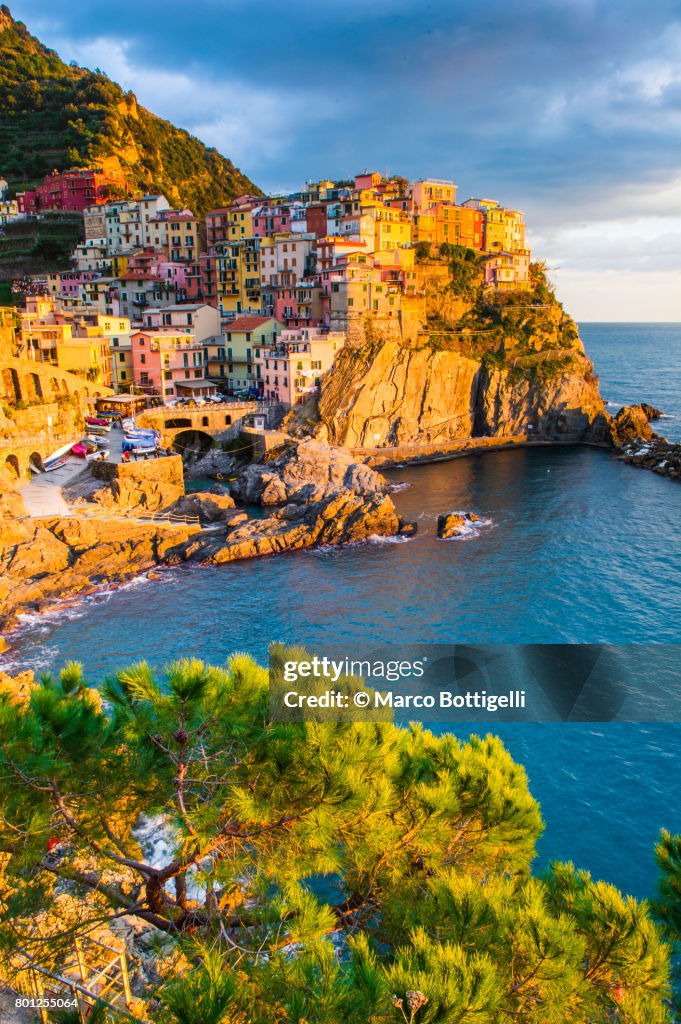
[0,440,416,634]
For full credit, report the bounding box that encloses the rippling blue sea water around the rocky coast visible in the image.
[0,324,681,897]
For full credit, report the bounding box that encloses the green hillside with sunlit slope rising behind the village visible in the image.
[0,5,259,213]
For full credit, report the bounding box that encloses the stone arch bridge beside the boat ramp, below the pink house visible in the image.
[135,401,272,454]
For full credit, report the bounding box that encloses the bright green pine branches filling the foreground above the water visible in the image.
[0,655,670,1024]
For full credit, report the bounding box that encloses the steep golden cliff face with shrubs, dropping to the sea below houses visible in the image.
[318,288,608,449]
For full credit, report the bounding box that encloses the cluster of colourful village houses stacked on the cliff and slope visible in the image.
[0,169,530,408]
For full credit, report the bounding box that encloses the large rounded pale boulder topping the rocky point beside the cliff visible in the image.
[231,439,386,505]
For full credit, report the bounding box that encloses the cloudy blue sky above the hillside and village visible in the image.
[9,0,681,322]
